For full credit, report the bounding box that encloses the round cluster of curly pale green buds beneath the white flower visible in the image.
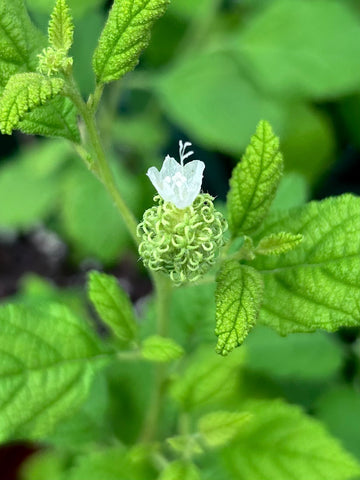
[137,194,227,285]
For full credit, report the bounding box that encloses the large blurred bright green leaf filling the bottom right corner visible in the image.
[224,401,360,480]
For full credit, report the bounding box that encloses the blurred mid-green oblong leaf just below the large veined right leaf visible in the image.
[246,325,345,382]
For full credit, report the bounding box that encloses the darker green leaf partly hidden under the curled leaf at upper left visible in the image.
[18,96,80,143]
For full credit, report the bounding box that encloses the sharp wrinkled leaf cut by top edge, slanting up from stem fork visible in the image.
[93,0,169,83]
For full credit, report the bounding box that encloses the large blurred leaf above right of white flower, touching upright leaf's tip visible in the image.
[153,53,285,156]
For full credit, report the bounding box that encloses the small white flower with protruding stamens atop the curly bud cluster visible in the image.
[146,140,205,209]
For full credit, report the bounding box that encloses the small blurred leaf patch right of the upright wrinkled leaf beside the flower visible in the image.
[270,172,309,212]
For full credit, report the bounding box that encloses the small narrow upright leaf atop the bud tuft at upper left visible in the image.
[48,0,74,55]
